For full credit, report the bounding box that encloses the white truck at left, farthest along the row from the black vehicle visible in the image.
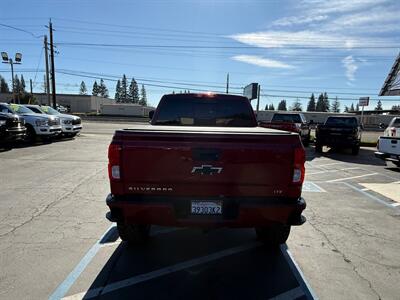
[25,105,82,137]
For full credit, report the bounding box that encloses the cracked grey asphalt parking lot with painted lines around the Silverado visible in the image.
[0,122,400,299]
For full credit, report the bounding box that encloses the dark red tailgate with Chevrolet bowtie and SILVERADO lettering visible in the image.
[114,129,301,197]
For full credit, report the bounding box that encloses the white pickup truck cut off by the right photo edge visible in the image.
[375,117,400,167]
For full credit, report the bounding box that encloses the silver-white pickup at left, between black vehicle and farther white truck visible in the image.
[0,103,61,141]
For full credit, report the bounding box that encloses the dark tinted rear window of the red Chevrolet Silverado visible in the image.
[153,96,257,127]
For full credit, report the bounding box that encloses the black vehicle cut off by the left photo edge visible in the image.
[0,107,26,147]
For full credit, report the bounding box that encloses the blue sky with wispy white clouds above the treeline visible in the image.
[0,0,400,109]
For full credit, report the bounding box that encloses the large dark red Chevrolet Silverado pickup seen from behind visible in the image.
[106,94,306,245]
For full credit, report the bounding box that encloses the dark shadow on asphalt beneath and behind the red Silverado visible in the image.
[84,229,312,299]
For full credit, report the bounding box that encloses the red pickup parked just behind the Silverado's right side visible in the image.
[260,113,311,146]
